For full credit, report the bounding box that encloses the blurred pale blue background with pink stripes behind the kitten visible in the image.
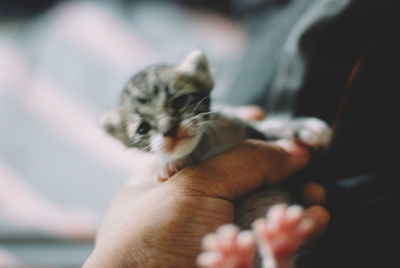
[0,0,315,267]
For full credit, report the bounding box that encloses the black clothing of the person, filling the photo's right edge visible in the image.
[286,0,400,268]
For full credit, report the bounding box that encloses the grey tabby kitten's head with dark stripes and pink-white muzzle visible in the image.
[102,50,213,158]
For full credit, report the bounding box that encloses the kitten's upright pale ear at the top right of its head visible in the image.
[176,50,214,91]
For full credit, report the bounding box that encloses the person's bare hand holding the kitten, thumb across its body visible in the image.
[83,140,329,268]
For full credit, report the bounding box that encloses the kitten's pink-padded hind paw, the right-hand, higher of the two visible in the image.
[253,205,313,268]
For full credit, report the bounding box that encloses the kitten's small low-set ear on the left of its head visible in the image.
[99,109,126,144]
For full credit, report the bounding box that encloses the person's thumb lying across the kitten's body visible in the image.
[178,140,310,200]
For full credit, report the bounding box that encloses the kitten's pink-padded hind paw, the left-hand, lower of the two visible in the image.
[197,224,255,268]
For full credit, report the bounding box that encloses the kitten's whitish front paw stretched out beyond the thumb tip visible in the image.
[296,118,332,148]
